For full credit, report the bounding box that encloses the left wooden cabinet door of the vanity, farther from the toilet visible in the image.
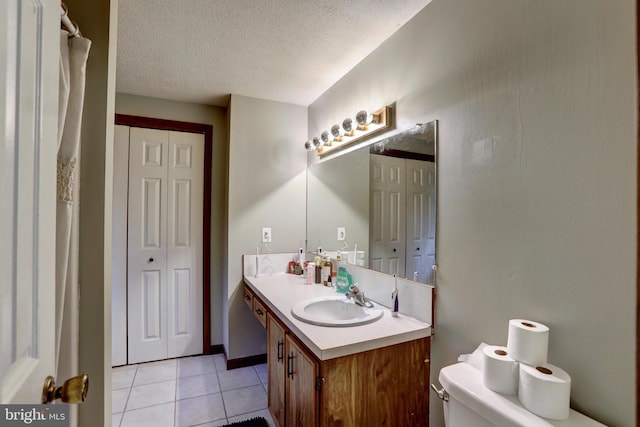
[267,313,285,427]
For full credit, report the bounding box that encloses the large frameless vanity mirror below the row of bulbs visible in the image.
[307,120,438,284]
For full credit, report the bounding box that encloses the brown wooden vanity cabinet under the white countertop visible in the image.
[253,288,431,427]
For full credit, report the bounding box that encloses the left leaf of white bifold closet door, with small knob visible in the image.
[127,128,169,363]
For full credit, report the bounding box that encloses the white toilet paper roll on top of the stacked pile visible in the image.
[507,319,549,365]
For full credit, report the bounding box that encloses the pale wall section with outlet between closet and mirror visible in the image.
[223,95,307,359]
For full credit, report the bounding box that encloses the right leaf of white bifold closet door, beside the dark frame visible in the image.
[167,132,204,357]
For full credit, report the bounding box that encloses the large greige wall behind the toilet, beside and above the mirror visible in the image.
[309,0,637,426]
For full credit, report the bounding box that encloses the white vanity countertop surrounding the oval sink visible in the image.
[244,273,431,360]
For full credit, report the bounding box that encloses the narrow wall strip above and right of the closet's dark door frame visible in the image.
[116,93,228,344]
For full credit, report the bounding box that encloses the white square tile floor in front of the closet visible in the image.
[112,354,275,427]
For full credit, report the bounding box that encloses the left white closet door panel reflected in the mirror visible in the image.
[369,154,406,277]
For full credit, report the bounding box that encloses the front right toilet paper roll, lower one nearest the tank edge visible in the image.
[518,363,571,420]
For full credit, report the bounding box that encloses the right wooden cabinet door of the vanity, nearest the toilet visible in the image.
[285,335,318,427]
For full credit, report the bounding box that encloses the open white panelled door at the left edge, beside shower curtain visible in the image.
[0,0,60,404]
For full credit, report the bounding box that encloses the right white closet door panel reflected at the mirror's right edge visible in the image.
[406,159,435,283]
